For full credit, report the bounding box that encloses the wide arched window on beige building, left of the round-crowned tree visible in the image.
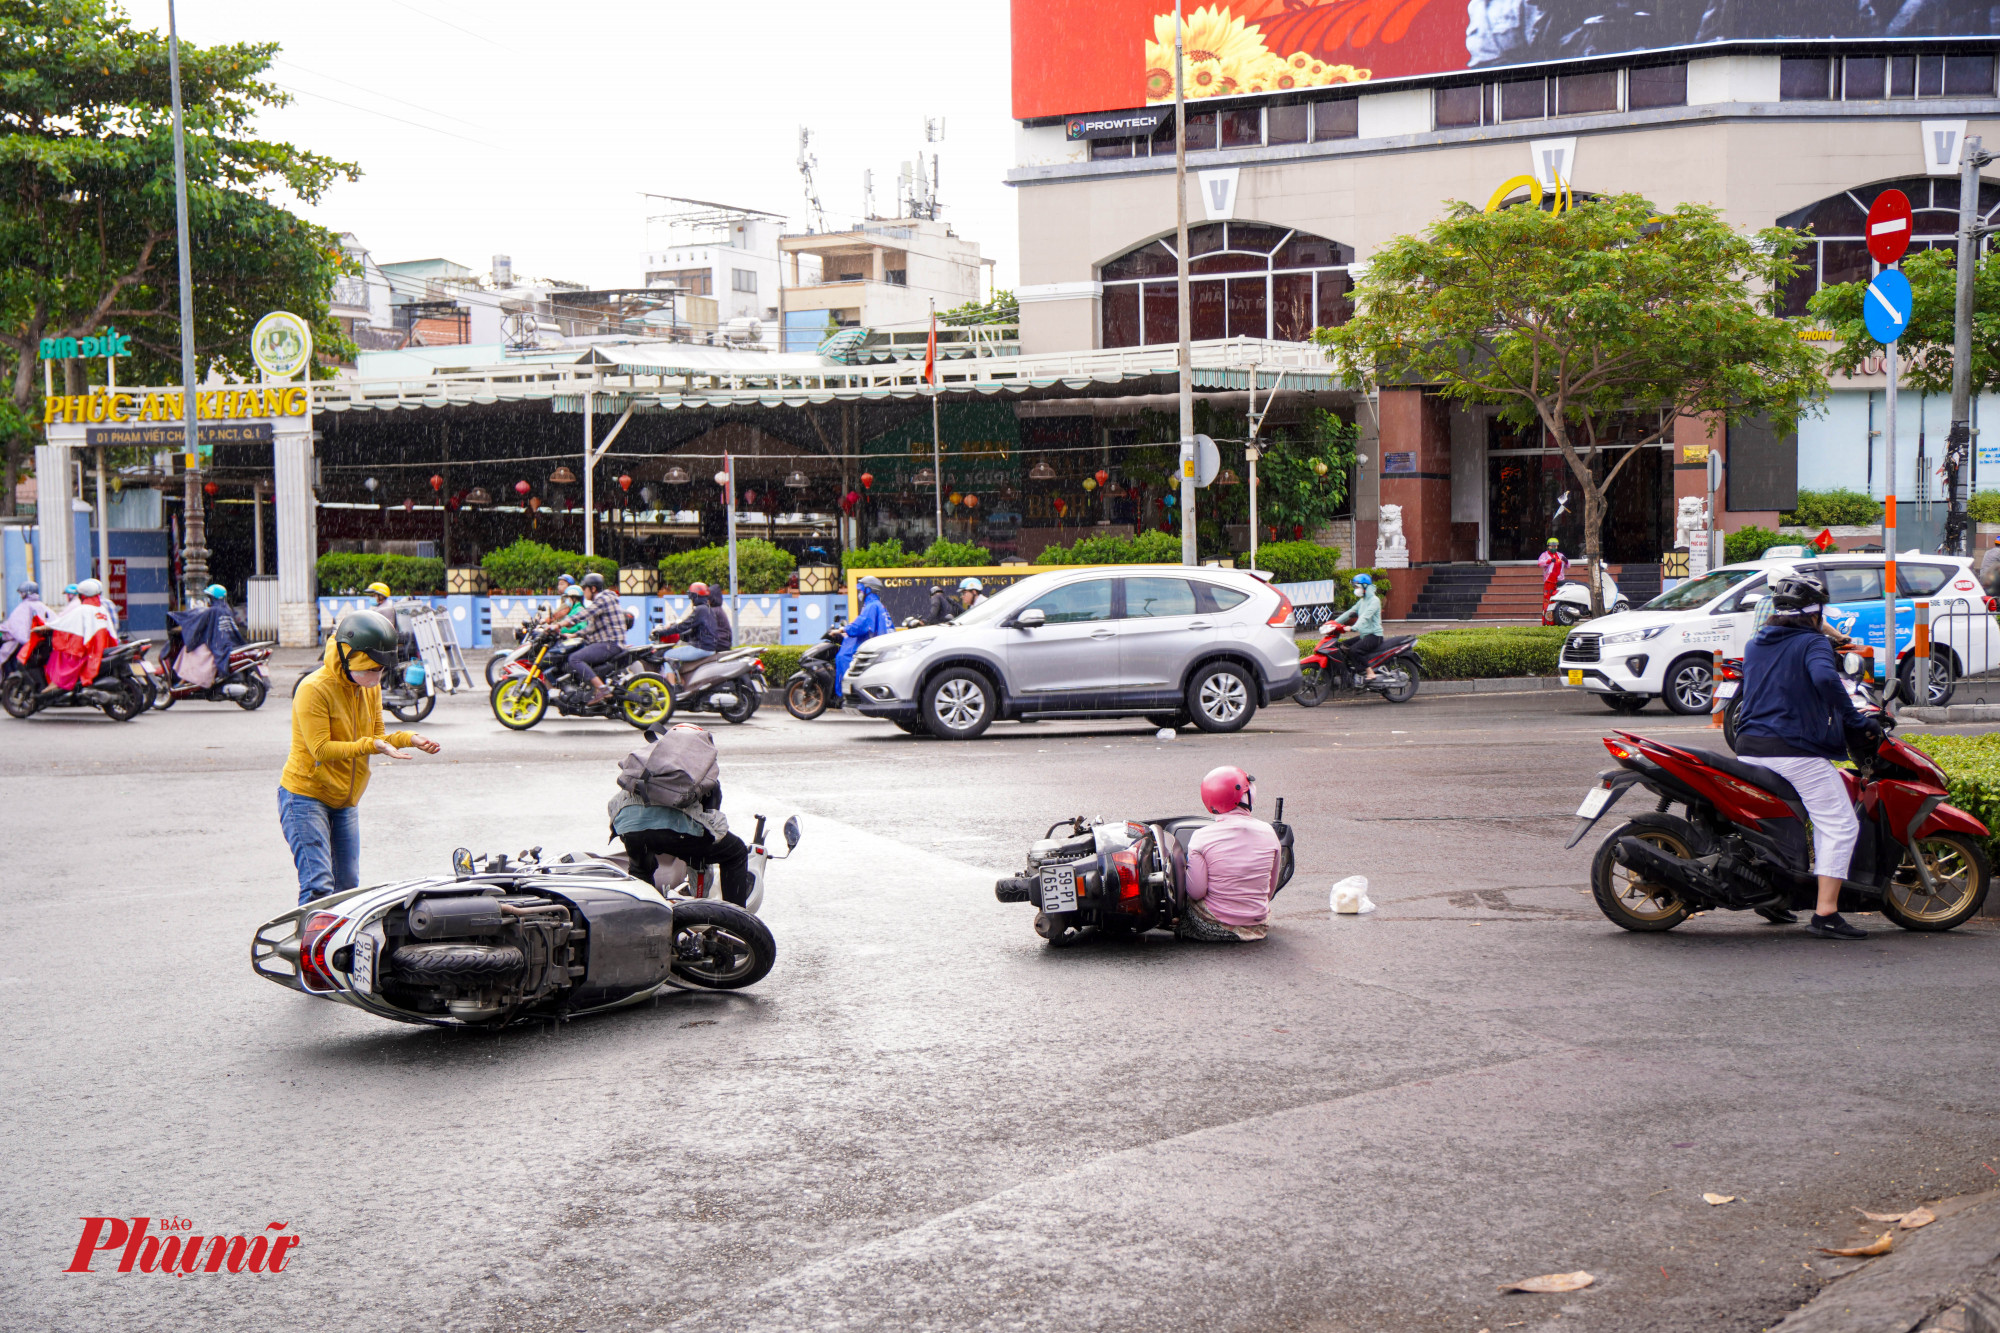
[1098,222,1354,346]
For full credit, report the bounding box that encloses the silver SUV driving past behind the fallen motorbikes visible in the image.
[844,564,1300,741]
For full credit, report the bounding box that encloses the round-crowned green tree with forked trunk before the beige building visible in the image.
[1314,194,1826,610]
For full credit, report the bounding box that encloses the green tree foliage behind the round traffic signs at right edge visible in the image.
[1806,250,2000,394]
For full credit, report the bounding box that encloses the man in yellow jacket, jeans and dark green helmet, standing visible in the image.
[278,610,440,907]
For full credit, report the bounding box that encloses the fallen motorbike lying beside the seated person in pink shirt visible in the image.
[994,797,1292,949]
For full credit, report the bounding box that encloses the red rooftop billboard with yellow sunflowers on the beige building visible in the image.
[1014,0,1992,120]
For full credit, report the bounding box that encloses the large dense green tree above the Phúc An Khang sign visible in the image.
[0,0,358,512]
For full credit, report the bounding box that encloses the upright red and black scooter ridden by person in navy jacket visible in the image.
[1566,652,1992,931]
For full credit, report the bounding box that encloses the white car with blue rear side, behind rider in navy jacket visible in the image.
[1560,550,2000,713]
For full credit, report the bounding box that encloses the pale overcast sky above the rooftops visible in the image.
[180,0,1018,286]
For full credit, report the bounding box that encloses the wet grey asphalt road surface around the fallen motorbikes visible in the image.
[0,673,2000,1333]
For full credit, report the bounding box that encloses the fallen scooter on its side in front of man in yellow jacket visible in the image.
[250,819,798,1029]
